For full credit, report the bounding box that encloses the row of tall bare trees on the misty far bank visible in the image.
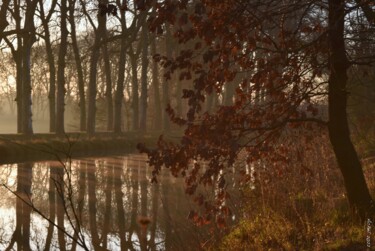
[0,0,236,135]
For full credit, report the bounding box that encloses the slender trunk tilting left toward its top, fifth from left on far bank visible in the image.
[69,0,86,131]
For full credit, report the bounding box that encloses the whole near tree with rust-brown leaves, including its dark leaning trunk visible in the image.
[139,0,375,221]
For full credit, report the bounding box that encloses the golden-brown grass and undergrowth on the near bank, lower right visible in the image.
[211,134,375,251]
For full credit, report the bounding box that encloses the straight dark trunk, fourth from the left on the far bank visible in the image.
[56,0,68,135]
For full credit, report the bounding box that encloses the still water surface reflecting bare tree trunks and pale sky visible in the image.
[0,155,232,250]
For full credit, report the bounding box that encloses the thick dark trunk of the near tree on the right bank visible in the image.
[328,0,372,220]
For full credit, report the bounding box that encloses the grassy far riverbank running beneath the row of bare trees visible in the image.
[0,131,180,164]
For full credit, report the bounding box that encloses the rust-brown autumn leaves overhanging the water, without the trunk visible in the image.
[139,0,375,225]
